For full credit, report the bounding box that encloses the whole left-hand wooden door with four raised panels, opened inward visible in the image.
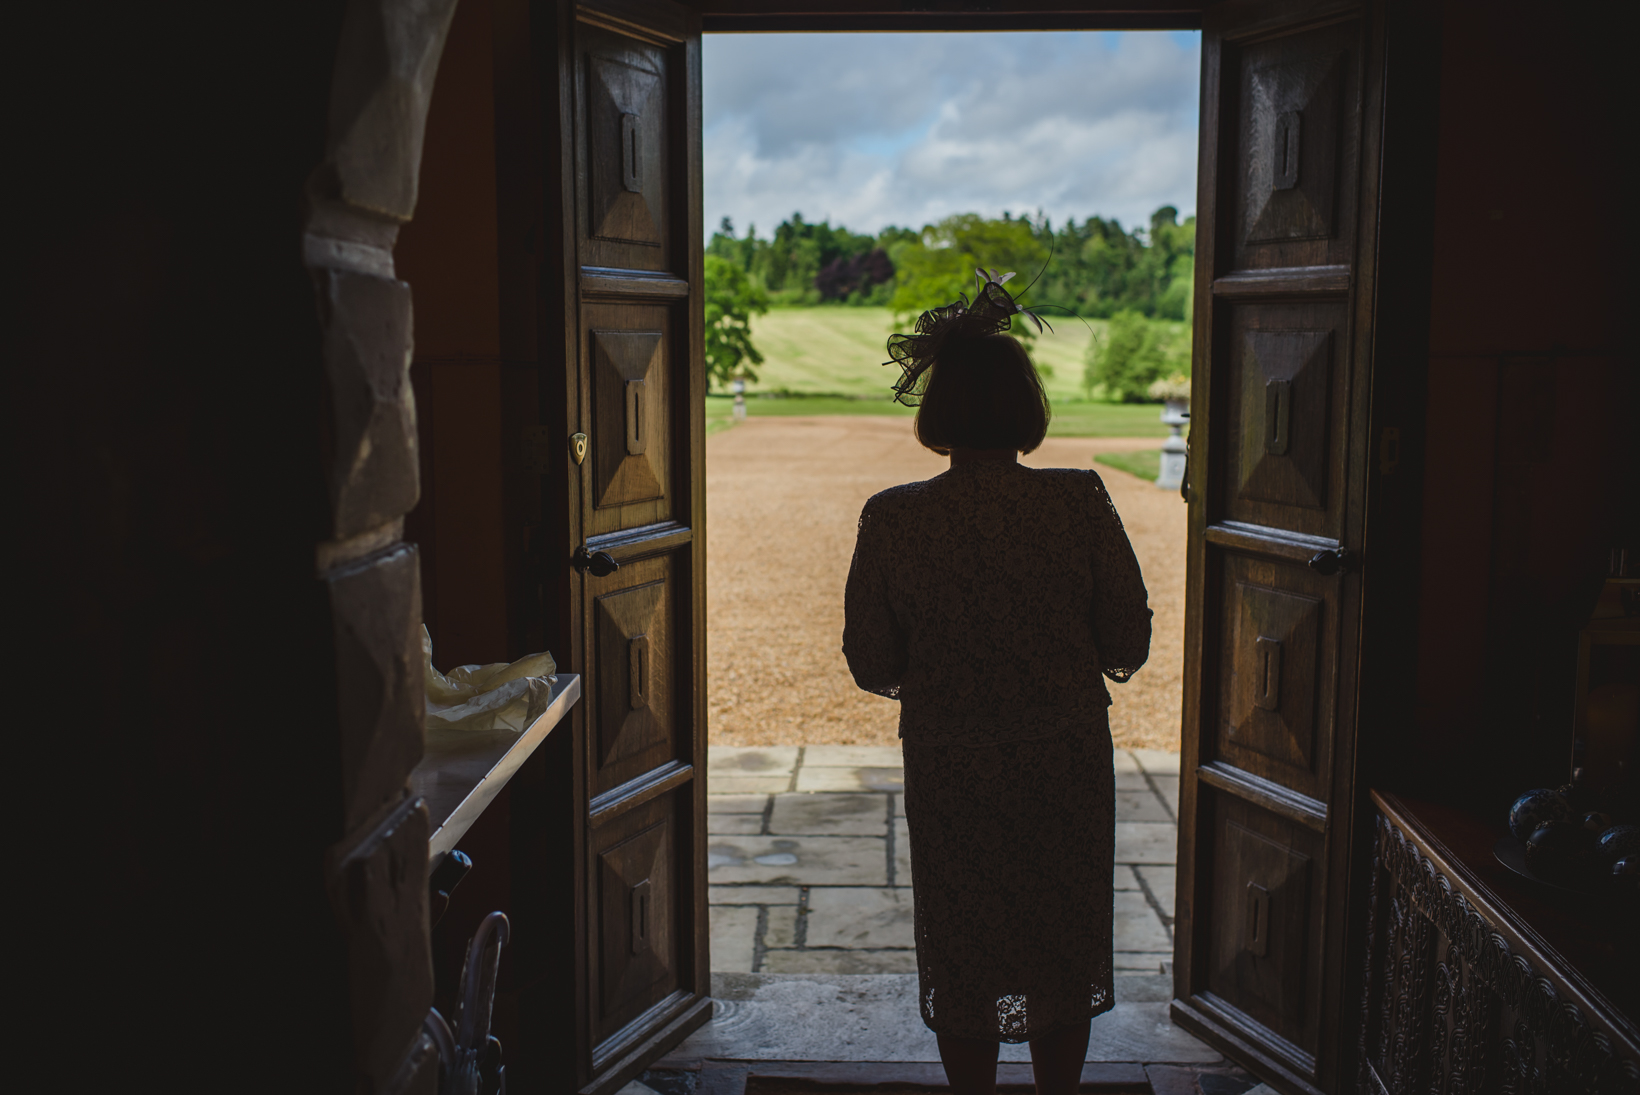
[549,0,712,1092]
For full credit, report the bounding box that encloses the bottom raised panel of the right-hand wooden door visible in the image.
[1209,795,1320,1052]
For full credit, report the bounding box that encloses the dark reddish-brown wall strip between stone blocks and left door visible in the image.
[394,0,511,669]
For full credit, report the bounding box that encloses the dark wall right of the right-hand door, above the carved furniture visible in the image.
[1404,0,1637,808]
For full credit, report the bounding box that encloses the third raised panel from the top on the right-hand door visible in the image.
[1225,582,1322,769]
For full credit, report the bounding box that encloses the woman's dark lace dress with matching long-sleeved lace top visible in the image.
[843,461,1150,1043]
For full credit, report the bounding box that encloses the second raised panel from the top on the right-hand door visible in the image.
[1238,331,1332,508]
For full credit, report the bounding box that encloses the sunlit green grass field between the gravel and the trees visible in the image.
[707,308,1168,439]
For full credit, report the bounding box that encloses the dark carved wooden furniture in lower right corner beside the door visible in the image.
[1358,792,1640,1095]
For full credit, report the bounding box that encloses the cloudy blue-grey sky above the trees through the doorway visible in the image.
[702,31,1200,236]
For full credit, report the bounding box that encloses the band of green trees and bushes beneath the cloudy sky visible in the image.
[707,205,1196,400]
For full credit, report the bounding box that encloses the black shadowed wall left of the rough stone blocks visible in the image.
[16,2,351,1092]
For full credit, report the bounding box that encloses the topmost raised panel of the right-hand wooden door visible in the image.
[1241,52,1345,243]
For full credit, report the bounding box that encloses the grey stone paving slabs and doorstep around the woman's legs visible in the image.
[623,746,1255,1095]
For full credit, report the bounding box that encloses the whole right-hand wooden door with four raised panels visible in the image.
[1174,3,1379,1092]
